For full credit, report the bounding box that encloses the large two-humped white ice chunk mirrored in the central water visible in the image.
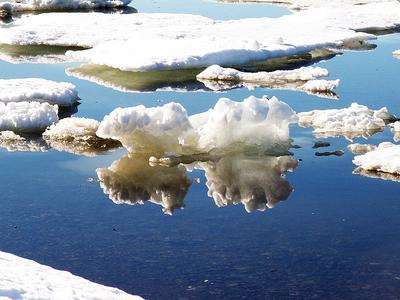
[96,97,297,154]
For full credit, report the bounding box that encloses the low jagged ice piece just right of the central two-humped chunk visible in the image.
[298,103,392,139]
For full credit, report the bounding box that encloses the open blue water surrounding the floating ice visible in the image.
[0,1,400,299]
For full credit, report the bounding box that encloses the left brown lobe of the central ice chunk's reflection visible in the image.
[96,154,192,214]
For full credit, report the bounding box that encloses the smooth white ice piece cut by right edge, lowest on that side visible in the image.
[353,142,400,175]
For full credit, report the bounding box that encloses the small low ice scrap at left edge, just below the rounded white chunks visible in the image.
[0,131,49,152]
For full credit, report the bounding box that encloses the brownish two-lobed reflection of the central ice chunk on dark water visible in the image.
[97,154,298,214]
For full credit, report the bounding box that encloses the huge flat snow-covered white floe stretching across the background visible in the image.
[0,1,400,71]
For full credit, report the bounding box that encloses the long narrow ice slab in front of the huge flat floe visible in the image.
[197,65,340,98]
